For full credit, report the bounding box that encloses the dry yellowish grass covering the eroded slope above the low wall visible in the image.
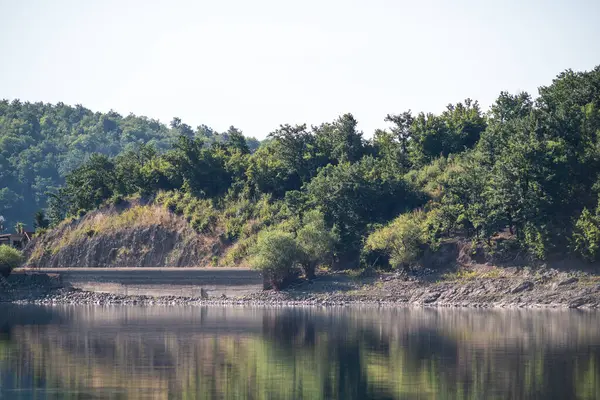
[27,202,231,266]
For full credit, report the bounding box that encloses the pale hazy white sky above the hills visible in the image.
[0,0,600,138]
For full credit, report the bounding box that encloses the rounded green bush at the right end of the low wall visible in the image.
[250,230,299,290]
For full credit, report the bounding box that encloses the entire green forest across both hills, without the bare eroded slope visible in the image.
[0,66,600,284]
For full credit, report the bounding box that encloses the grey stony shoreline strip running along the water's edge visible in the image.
[0,265,600,309]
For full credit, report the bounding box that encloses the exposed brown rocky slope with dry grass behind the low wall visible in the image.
[25,206,222,268]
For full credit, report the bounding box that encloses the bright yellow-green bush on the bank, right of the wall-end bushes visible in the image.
[365,211,429,268]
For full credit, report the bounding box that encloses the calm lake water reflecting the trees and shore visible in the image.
[0,305,600,399]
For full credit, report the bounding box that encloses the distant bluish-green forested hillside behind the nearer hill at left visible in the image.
[0,100,258,232]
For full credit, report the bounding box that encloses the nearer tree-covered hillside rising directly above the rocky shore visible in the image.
[9,66,600,287]
